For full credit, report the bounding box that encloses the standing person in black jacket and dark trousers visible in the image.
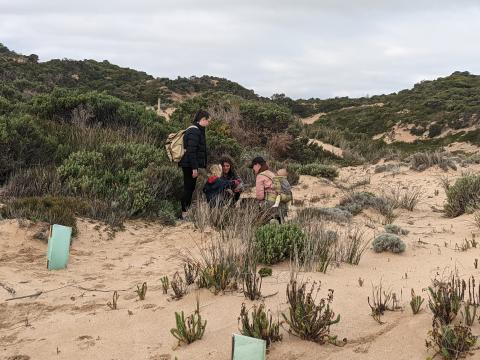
[178,110,210,219]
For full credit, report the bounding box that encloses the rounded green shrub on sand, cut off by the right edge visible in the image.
[445,174,480,217]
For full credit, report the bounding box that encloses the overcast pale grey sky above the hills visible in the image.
[0,0,480,98]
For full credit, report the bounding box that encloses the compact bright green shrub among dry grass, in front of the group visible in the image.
[255,224,305,265]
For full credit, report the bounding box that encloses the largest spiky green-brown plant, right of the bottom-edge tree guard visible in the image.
[282,280,340,344]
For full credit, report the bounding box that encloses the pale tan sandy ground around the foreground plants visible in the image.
[0,165,480,360]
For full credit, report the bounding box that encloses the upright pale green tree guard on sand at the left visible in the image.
[47,224,72,270]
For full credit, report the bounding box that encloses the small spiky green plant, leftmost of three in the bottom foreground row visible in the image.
[170,299,207,345]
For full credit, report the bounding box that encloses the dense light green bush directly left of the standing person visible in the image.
[58,144,182,215]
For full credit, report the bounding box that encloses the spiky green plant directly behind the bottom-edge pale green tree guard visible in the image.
[238,303,282,347]
